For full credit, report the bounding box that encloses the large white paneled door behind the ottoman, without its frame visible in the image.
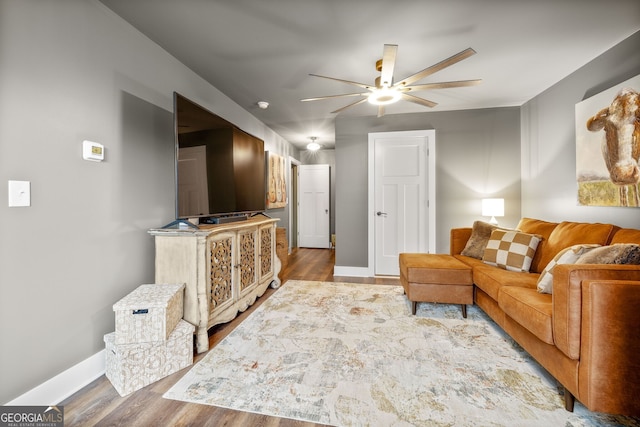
[369,131,435,276]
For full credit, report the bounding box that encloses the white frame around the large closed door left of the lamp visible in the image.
[367,129,437,277]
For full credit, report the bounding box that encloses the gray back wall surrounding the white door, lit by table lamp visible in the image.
[336,108,520,267]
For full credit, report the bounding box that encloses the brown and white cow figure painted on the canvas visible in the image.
[587,88,640,206]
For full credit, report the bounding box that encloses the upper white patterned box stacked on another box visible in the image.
[113,284,184,344]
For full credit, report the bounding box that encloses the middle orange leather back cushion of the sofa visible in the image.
[532,221,620,273]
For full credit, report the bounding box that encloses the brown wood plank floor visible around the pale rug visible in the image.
[60,249,400,427]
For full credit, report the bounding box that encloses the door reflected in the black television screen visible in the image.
[178,145,209,217]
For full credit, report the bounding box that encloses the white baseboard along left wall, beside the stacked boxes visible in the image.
[6,350,105,406]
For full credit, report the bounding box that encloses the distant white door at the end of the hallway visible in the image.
[298,165,330,248]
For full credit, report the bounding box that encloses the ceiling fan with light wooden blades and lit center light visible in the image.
[301,44,482,117]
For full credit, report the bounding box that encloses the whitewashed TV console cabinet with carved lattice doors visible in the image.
[149,215,281,353]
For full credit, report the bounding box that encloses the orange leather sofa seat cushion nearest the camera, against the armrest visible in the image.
[498,286,553,345]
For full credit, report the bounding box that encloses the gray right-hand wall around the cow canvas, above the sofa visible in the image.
[521,32,640,228]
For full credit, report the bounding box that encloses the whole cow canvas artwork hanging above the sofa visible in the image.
[576,75,640,207]
